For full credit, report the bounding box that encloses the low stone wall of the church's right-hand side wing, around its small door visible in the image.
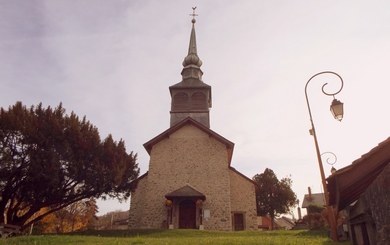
[230,170,257,230]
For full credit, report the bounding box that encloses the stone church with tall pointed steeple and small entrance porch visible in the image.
[129,14,257,231]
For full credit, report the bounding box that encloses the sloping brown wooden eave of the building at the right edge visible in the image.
[327,137,390,210]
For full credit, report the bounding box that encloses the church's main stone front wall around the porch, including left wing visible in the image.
[130,124,232,230]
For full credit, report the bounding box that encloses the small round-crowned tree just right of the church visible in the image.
[253,168,297,229]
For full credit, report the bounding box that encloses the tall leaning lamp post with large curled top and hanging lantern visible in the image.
[305,71,344,241]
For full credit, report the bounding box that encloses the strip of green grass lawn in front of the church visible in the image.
[0,230,349,245]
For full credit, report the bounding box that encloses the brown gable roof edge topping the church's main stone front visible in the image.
[144,117,234,166]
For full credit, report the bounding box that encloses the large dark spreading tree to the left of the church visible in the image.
[0,102,139,228]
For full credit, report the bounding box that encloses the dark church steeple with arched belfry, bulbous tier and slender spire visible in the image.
[169,7,211,127]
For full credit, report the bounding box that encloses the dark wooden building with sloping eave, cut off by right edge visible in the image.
[327,137,390,245]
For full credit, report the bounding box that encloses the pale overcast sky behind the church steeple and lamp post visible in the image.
[0,0,390,214]
